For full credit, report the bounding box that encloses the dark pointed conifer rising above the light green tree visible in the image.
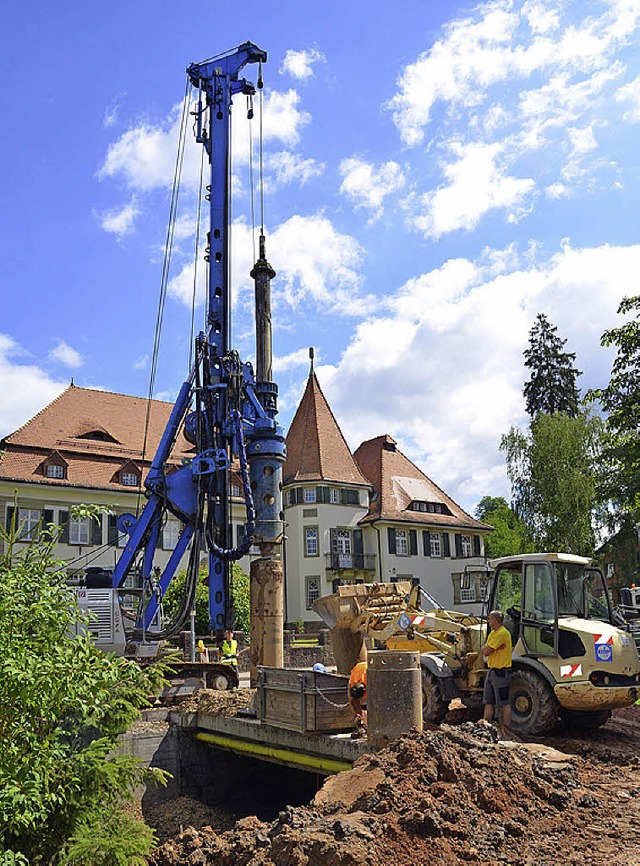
[523,313,582,418]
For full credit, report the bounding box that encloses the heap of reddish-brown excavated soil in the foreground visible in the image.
[149,701,640,866]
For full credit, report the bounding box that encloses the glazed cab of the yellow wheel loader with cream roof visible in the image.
[489,553,613,656]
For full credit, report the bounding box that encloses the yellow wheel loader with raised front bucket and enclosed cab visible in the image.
[314,553,640,736]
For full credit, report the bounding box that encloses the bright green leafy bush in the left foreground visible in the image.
[0,525,162,866]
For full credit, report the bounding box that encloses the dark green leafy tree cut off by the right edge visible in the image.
[588,295,640,524]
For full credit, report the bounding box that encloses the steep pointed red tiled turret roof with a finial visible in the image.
[283,371,369,486]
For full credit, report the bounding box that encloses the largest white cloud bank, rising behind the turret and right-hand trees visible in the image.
[318,243,640,508]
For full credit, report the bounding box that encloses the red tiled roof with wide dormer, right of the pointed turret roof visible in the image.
[353,435,491,532]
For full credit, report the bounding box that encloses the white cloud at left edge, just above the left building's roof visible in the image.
[0,334,69,436]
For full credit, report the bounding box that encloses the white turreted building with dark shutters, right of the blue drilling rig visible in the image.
[283,370,492,623]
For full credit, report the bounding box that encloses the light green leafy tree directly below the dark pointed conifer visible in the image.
[500,412,604,555]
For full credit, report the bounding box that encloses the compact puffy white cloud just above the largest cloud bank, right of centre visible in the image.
[408,143,534,238]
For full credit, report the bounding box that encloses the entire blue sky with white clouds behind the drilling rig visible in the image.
[0,0,640,508]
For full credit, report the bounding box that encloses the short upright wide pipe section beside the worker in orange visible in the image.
[367,650,422,749]
